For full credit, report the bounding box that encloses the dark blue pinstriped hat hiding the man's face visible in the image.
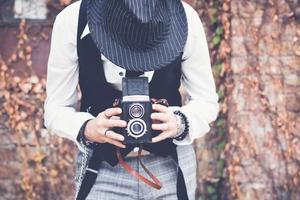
[87,0,188,72]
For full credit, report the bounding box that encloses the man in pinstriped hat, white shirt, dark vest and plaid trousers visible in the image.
[44,0,219,200]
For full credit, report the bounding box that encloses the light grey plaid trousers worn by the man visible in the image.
[76,145,196,200]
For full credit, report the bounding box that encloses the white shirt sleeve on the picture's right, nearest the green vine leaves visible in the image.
[170,5,219,145]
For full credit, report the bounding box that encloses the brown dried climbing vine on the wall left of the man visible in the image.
[0,1,75,200]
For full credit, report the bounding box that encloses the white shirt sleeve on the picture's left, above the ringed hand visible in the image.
[44,10,94,151]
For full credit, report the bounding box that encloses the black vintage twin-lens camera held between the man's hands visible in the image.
[120,77,152,144]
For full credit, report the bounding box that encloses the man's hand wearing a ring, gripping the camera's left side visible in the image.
[84,108,127,148]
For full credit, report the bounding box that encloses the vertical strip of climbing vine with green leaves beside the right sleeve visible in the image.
[196,0,230,200]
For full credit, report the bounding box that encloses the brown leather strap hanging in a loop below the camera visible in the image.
[116,146,162,190]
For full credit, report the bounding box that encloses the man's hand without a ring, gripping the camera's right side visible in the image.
[151,104,177,142]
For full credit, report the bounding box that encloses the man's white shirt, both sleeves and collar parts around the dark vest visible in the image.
[44,1,219,150]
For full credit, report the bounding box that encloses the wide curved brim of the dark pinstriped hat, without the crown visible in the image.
[87,0,188,71]
